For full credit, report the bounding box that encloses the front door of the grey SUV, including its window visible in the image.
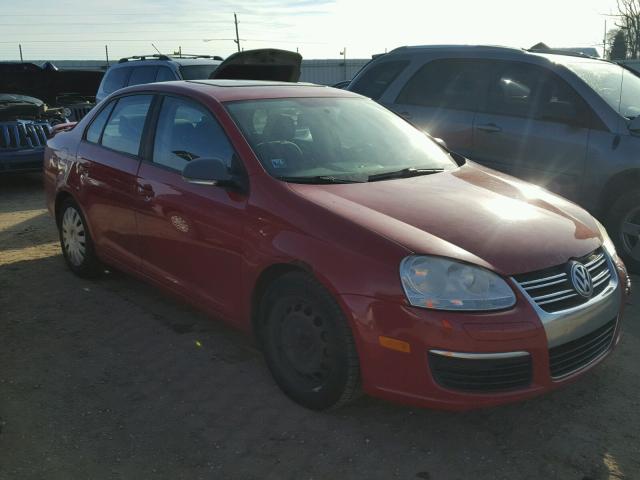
[470,62,594,199]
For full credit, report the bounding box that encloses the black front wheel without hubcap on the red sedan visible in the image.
[260,272,360,410]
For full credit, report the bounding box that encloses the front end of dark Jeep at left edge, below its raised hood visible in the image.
[0,93,67,174]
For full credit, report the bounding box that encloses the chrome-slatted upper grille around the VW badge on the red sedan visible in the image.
[513,248,612,313]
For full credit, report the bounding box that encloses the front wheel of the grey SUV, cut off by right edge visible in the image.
[607,190,640,273]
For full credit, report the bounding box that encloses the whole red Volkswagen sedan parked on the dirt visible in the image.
[45,80,630,409]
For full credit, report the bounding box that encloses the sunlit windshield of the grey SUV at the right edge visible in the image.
[564,62,640,119]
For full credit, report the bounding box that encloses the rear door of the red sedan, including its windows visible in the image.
[78,95,153,269]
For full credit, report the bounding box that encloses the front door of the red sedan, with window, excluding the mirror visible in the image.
[137,96,247,315]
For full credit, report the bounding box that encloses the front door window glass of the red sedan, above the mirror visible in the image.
[153,97,234,171]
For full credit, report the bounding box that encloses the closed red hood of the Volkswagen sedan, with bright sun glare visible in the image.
[290,162,602,275]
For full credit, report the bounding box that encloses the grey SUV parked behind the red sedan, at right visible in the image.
[347,46,640,271]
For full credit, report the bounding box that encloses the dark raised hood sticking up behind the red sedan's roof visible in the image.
[210,48,302,82]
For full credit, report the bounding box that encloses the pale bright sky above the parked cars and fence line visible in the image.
[0,0,617,61]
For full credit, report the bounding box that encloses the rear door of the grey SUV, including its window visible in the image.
[387,59,489,156]
